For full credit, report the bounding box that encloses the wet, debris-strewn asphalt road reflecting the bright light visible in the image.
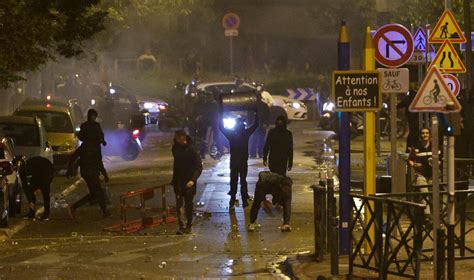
[0,122,328,279]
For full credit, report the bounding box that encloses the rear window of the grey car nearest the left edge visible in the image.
[0,123,40,147]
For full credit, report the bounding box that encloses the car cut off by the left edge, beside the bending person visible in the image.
[0,137,22,228]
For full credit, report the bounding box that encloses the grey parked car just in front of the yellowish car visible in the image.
[0,116,53,163]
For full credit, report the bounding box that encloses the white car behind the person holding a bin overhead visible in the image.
[197,82,308,122]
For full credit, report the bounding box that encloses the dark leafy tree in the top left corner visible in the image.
[0,0,107,88]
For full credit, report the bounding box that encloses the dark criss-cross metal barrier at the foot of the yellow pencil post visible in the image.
[349,193,425,279]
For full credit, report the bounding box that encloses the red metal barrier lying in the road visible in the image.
[104,184,176,233]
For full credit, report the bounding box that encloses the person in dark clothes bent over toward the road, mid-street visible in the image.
[248,171,293,232]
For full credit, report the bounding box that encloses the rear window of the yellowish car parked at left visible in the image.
[17,111,74,133]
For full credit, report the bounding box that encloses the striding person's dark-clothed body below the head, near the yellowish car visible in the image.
[66,142,111,219]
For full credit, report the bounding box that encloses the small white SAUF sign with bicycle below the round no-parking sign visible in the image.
[377,68,410,93]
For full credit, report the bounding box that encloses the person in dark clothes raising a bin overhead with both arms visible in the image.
[219,114,259,211]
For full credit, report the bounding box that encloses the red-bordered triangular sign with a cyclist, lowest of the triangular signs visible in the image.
[409,67,461,112]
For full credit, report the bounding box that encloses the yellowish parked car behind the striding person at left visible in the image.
[13,100,80,171]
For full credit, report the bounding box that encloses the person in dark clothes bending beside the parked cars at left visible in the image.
[20,156,54,220]
